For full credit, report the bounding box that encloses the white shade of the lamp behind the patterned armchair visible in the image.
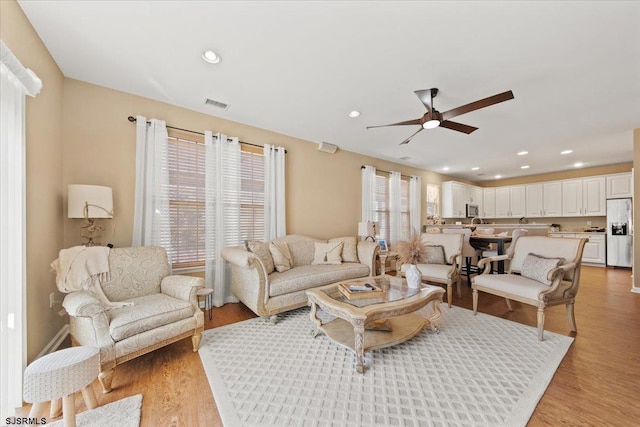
[67,184,113,218]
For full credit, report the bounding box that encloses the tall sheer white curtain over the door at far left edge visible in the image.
[0,40,42,424]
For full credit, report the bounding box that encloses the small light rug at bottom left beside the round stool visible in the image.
[47,394,142,427]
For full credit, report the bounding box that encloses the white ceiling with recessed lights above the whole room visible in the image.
[19,0,640,181]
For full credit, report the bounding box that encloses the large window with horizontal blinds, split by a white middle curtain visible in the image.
[168,137,264,268]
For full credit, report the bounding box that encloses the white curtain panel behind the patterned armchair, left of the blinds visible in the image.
[132,116,172,254]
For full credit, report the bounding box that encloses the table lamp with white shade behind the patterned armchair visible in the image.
[67,184,113,246]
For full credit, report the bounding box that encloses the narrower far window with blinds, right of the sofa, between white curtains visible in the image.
[375,172,411,242]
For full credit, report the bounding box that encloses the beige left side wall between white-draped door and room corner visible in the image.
[0,0,66,362]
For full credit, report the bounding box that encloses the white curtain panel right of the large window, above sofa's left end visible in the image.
[263,144,287,241]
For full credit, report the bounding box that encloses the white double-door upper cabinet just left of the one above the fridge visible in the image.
[562,176,607,216]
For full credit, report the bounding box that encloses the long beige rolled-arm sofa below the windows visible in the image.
[222,235,379,323]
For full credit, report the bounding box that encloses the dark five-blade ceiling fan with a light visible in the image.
[367,88,513,145]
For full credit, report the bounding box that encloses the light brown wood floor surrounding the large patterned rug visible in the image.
[19,266,640,427]
